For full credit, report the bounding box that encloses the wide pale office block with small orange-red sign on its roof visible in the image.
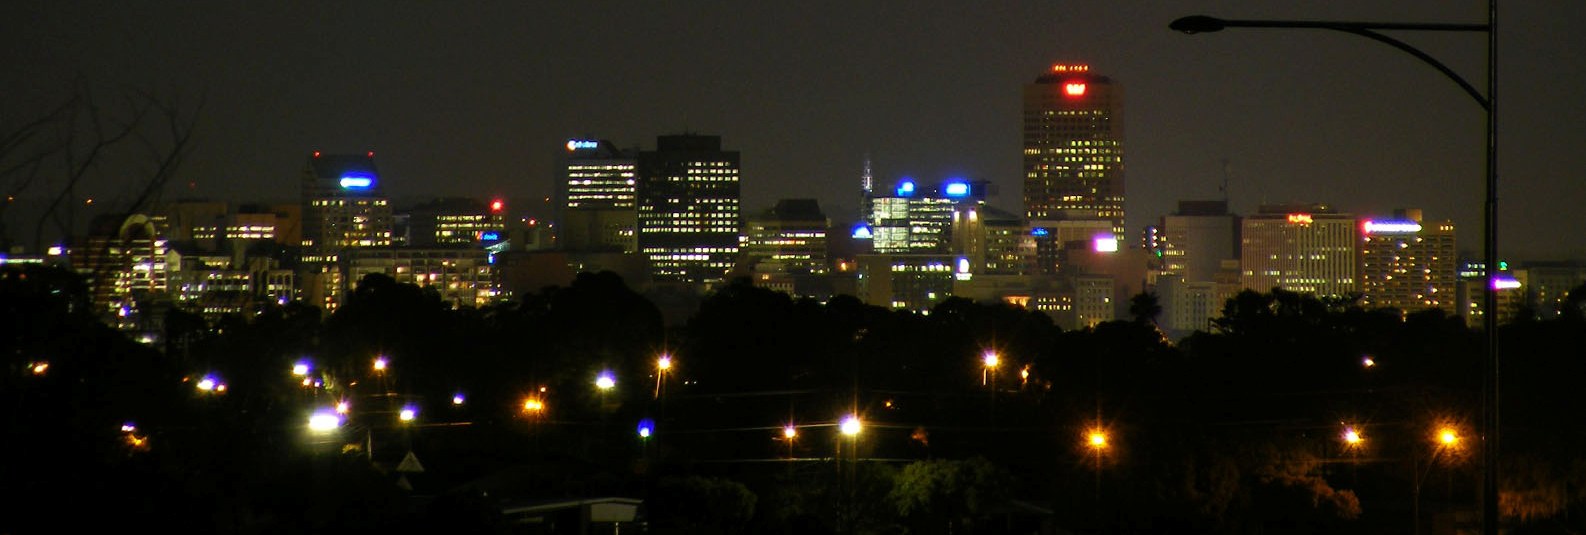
[1239,205,1359,295]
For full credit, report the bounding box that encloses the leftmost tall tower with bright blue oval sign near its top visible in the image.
[298,151,392,307]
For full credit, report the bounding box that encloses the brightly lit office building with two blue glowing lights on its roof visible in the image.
[866,178,988,254]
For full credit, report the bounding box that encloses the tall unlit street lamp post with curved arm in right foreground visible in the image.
[1169,10,1499,535]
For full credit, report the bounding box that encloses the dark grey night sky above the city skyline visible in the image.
[9,0,1586,259]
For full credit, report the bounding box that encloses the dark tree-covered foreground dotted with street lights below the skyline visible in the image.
[0,268,1586,533]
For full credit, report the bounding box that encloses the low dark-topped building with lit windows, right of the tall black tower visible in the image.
[744,198,831,275]
